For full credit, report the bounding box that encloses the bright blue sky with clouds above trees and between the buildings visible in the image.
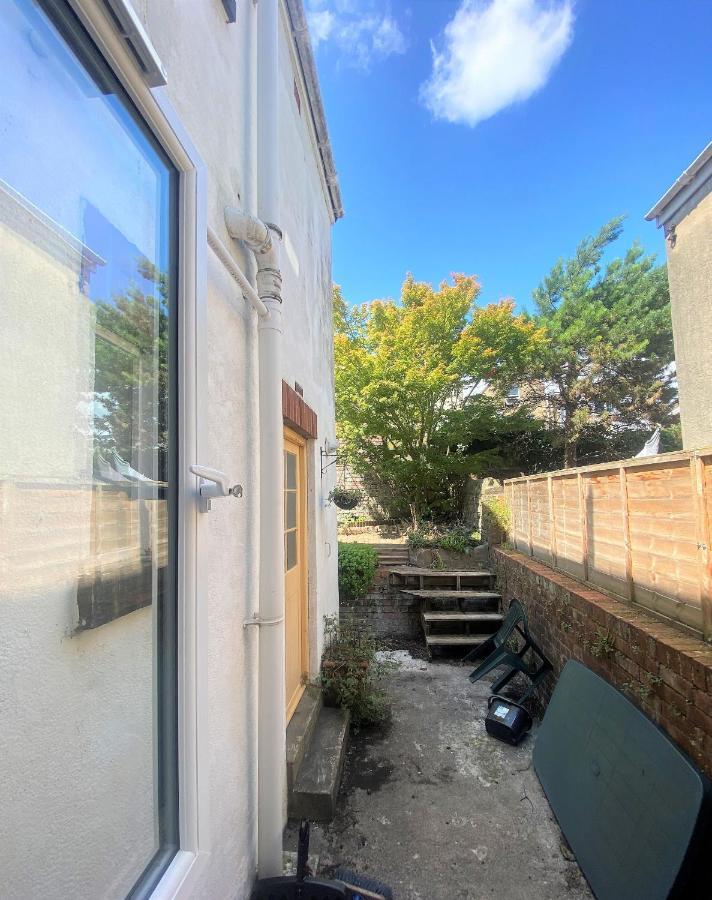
[307,0,712,308]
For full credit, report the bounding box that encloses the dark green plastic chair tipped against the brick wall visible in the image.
[462,600,552,700]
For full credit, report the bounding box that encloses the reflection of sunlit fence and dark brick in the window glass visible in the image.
[0,480,169,630]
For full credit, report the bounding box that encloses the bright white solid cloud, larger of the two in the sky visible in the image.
[420,0,574,126]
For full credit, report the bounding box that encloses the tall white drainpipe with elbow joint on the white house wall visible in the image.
[225,0,286,878]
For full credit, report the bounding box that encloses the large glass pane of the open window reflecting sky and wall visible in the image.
[0,0,177,898]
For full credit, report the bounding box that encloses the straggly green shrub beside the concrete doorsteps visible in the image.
[320,616,396,725]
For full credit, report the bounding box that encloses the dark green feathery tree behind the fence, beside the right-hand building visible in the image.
[526,218,677,467]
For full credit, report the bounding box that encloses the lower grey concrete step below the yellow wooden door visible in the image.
[289,706,349,822]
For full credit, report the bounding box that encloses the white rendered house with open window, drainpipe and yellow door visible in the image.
[0,0,342,900]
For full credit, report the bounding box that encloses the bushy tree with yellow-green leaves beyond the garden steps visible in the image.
[334,275,543,526]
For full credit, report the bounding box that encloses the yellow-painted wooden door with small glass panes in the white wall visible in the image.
[284,429,309,721]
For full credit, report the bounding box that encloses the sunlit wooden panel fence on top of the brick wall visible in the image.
[504,448,712,640]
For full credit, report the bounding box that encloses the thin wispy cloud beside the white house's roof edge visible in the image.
[307,0,407,70]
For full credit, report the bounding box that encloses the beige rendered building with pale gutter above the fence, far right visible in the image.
[645,143,712,450]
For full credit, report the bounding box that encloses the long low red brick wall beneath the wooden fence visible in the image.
[493,548,712,776]
